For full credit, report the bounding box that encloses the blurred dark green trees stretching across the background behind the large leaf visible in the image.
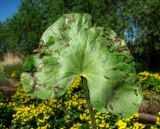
[0,0,160,69]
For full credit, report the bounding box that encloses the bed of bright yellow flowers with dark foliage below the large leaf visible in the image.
[0,72,160,129]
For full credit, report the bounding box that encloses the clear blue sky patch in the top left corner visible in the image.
[0,0,21,22]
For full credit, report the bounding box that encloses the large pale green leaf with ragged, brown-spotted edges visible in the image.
[21,13,142,116]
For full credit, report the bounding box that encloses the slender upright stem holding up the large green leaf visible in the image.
[81,77,97,129]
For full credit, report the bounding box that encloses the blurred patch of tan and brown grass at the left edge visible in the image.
[0,52,22,96]
